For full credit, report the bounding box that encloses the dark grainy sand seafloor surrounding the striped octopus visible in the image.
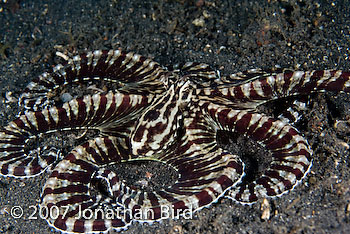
[0,0,350,233]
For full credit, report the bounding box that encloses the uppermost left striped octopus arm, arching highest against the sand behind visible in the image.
[19,50,168,111]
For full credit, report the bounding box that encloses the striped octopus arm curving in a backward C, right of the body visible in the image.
[203,103,312,203]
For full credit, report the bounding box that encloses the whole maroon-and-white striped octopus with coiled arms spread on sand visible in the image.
[0,50,350,233]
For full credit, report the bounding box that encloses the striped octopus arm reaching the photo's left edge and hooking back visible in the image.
[0,93,149,177]
